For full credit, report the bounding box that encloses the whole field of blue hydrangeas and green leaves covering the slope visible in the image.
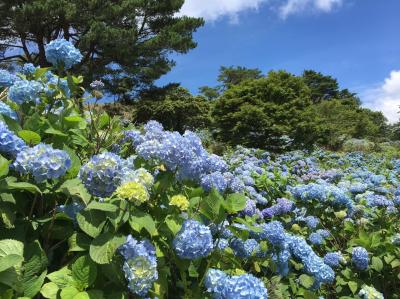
[0,40,400,299]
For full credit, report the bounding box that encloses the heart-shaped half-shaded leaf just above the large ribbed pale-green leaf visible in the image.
[76,210,106,238]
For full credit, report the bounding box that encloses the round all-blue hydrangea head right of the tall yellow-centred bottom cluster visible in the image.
[173,219,213,260]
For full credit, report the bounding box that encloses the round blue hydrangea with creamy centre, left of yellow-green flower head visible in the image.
[79,152,125,197]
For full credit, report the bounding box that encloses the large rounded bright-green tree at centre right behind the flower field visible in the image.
[212,71,313,149]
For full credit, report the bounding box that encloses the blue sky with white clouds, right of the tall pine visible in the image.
[159,0,400,122]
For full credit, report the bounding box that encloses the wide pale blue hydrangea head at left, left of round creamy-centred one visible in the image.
[13,143,71,182]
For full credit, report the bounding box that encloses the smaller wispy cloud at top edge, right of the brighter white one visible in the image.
[278,0,343,19]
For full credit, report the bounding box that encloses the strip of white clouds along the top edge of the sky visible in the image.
[179,0,344,22]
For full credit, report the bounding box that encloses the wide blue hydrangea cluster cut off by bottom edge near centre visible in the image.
[204,269,268,299]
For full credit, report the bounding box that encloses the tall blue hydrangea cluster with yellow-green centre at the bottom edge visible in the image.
[119,235,158,296]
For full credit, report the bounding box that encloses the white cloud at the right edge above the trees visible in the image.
[360,70,400,123]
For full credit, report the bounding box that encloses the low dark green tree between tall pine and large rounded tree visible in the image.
[134,87,211,133]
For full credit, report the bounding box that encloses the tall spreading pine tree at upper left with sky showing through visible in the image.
[0,0,204,95]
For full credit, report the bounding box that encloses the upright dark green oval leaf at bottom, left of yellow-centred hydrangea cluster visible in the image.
[71,255,97,290]
